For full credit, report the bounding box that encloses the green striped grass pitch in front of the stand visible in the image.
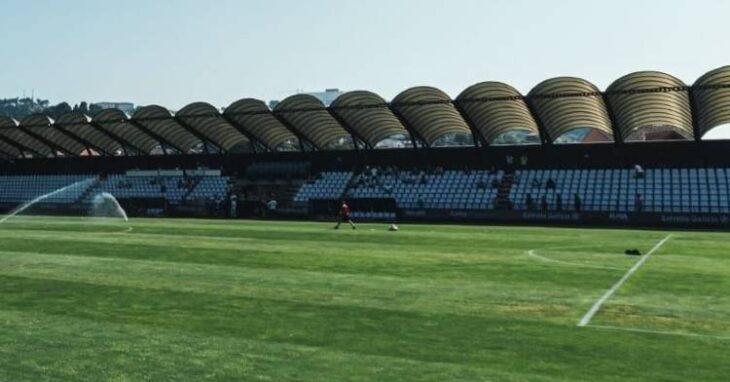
[0,218,730,382]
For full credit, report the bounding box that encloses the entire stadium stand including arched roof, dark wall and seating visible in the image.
[0,66,730,227]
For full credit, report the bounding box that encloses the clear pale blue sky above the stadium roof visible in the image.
[0,0,730,109]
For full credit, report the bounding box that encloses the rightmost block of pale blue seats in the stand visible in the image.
[510,168,730,213]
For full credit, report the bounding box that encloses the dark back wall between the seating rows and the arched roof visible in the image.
[0,141,730,175]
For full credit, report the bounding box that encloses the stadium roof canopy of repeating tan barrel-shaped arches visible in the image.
[0,66,730,158]
